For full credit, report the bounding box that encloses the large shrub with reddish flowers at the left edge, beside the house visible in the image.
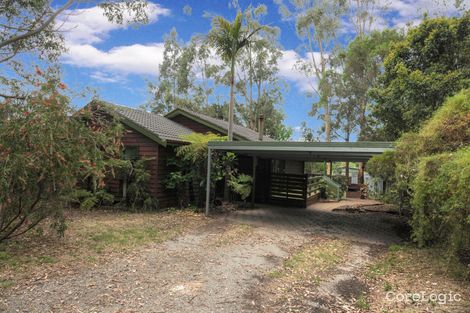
[0,73,120,241]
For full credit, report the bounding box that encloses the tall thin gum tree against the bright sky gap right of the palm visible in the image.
[277,0,346,142]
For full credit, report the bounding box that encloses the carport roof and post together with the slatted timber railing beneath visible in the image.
[206,141,393,214]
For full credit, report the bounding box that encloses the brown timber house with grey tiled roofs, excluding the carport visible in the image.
[90,100,272,207]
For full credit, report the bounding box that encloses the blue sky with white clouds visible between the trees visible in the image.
[54,0,470,139]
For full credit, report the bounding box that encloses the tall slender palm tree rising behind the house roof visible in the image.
[208,11,262,141]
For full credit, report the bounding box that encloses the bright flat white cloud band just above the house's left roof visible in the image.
[63,43,164,75]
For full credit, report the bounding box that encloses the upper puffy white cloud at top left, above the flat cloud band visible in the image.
[57,2,170,44]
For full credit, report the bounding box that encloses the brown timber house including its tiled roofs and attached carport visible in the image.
[84,100,393,211]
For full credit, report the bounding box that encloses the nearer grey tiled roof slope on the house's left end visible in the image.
[106,103,193,142]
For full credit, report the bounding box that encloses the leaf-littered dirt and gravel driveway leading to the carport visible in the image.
[0,201,401,312]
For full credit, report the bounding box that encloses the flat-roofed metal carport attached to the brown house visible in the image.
[206,141,394,214]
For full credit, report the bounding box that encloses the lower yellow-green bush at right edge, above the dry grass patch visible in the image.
[411,146,470,266]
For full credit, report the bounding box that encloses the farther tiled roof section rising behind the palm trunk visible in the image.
[165,108,274,141]
